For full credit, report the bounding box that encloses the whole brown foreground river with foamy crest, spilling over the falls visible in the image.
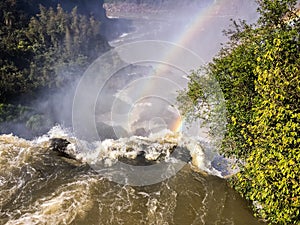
[0,126,260,225]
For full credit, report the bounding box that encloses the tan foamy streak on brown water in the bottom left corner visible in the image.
[6,178,98,225]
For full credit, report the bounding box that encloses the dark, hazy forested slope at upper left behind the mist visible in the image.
[0,0,110,135]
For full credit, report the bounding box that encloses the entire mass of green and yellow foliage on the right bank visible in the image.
[178,0,300,224]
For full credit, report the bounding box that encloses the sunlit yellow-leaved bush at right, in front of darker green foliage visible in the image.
[235,18,300,224]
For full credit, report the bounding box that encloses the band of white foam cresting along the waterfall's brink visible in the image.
[0,126,233,181]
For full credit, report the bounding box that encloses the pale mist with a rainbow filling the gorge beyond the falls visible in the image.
[2,0,257,139]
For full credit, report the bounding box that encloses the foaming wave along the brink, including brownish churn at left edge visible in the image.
[0,126,235,183]
